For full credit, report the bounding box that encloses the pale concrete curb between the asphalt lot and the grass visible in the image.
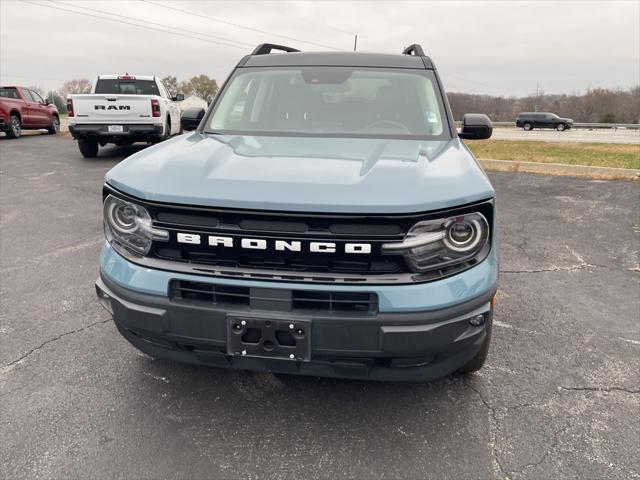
[478,159,640,181]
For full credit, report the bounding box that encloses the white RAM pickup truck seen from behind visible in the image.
[67,74,184,158]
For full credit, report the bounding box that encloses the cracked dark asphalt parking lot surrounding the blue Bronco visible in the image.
[0,135,640,479]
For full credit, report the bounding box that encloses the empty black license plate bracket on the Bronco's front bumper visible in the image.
[227,316,311,362]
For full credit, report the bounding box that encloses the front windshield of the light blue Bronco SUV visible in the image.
[208,67,449,138]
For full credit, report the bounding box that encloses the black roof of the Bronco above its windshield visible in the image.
[238,52,435,70]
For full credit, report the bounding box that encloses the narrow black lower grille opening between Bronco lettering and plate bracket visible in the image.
[169,280,378,315]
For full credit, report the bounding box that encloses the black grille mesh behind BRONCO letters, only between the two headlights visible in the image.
[149,202,415,277]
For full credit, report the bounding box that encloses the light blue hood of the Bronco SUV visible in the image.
[106,132,494,213]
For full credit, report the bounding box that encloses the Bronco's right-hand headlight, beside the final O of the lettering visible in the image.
[382,212,489,272]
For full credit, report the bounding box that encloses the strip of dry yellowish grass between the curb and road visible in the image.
[467,140,640,169]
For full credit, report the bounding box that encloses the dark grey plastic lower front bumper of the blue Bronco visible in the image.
[96,273,495,381]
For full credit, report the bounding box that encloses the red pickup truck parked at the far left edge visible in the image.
[0,87,60,138]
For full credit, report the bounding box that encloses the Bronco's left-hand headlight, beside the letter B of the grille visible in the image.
[103,195,169,255]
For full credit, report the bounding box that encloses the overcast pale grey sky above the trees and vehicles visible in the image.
[0,0,640,96]
